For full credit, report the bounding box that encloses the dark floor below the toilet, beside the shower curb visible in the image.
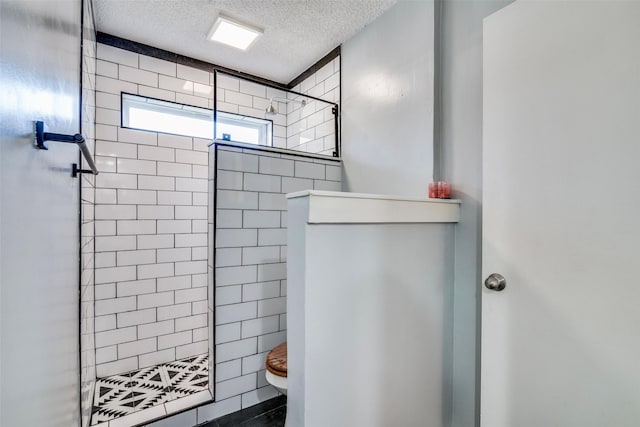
[199,396,287,427]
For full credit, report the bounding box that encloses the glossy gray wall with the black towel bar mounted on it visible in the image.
[0,1,81,427]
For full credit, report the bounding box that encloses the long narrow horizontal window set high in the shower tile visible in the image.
[122,93,273,146]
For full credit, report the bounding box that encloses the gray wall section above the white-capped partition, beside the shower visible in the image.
[341,1,434,196]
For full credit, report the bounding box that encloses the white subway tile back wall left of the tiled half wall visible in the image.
[94,44,213,377]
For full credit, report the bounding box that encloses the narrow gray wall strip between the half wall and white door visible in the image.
[436,0,511,427]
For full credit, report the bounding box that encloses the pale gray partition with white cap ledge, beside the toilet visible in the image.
[287,191,459,427]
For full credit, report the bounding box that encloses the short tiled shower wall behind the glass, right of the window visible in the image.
[286,56,340,155]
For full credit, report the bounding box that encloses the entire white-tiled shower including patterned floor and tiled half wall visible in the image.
[82,26,341,426]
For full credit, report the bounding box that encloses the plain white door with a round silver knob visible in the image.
[481,1,640,427]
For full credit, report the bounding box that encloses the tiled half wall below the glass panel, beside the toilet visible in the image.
[209,145,341,409]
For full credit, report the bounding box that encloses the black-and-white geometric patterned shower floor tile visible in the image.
[91,354,209,425]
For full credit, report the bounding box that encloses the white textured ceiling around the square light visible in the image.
[94,0,397,83]
